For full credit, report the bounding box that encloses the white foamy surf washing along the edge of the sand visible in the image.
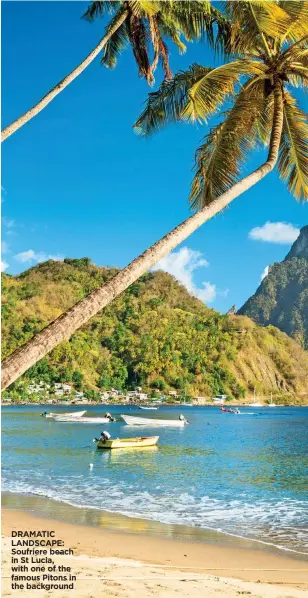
[2,472,308,555]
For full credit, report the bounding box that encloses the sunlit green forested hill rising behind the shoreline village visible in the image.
[3,258,308,401]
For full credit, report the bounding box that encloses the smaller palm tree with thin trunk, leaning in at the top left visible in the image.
[1,0,228,141]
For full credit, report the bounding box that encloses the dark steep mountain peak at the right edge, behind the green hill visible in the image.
[238,226,308,348]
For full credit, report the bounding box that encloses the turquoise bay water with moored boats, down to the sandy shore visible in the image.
[2,406,308,553]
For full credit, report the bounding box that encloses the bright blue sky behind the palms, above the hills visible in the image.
[2,2,308,312]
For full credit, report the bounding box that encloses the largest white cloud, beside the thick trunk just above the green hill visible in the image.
[152,247,228,303]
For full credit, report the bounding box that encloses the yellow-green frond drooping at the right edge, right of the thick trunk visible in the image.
[278,92,308,201]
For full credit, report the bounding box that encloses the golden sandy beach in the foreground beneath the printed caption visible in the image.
[2,509,308,598]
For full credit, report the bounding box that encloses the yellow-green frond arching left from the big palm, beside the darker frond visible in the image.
[181,60,266,122]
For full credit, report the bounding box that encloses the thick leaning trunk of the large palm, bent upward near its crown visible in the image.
[2,82,283,388]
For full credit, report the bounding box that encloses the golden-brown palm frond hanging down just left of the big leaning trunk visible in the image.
[189,81,268,209]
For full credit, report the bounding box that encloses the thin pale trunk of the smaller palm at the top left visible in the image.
[1,11,128,141]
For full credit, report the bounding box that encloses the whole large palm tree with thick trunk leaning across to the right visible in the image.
[2,0,308,388]
